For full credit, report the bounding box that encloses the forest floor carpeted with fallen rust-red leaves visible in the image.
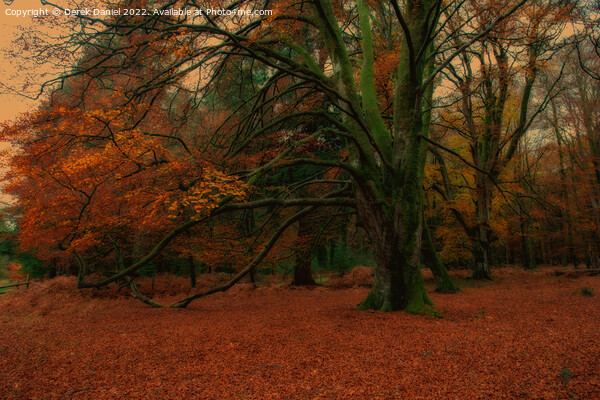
[0,268,600,400]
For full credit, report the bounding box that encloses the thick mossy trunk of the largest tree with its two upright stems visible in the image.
[344,0,437,313]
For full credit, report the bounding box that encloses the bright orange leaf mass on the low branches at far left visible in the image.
[2,101,246,256]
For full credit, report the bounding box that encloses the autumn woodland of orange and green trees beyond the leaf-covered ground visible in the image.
[2,1,600,310]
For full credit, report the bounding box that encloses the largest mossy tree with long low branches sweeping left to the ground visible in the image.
[3,0,525,313]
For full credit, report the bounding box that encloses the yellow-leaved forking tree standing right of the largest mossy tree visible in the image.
[426,2,572,280]
